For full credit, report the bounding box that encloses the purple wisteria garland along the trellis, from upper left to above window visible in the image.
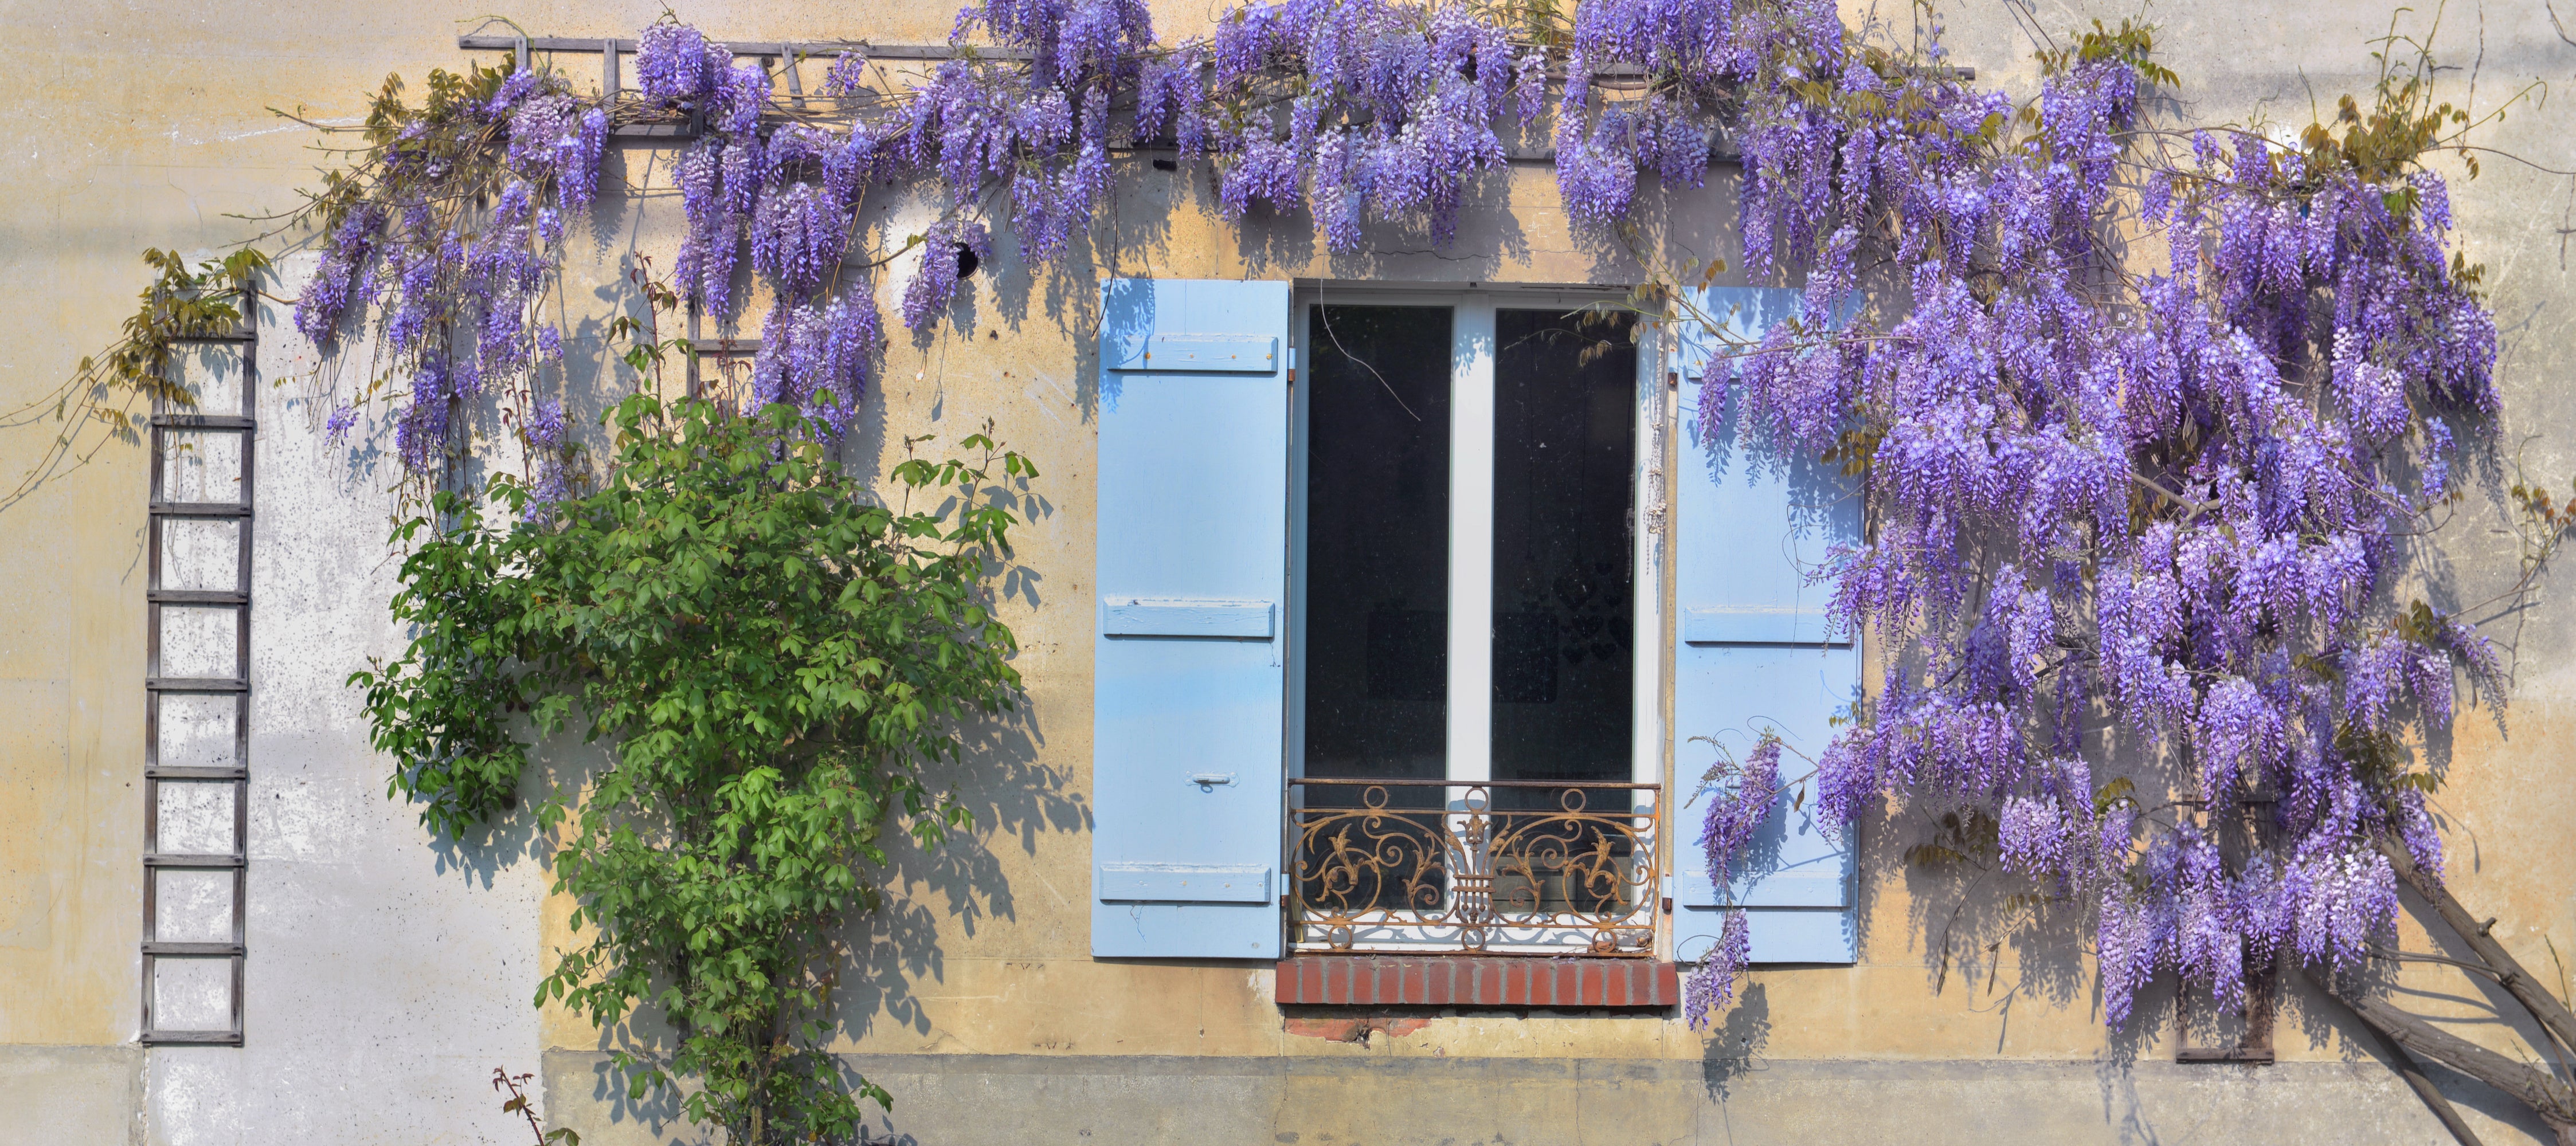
[299,0,1839,471]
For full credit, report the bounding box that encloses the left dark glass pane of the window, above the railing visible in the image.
[1303,307,1450,806]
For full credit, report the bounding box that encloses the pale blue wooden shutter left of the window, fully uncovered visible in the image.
[1092,278,1288,958]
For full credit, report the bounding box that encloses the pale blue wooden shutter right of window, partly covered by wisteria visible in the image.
[1672,286,1860,963]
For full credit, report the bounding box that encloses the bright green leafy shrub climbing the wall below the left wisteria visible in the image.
[350,397,1036,1144]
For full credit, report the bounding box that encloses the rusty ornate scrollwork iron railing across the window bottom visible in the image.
[1288,780,1664,958]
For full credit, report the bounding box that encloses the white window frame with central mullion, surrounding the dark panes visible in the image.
[1281,281,1680,958]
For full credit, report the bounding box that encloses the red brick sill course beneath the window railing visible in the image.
[1278,955,1682,1007]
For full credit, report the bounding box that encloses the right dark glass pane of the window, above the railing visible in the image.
[1494,309,1636,809]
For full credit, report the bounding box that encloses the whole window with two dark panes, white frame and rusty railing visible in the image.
[1288,291,1662,953]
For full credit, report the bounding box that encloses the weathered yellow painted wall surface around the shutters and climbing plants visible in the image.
[0,0,2576,1138]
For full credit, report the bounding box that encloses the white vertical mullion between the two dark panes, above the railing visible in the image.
[1448,299,1494,780]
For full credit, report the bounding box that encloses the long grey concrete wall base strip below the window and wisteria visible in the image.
[546,1051,2535,1146]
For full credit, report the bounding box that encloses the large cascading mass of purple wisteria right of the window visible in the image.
[1703,28,2504,1025]
